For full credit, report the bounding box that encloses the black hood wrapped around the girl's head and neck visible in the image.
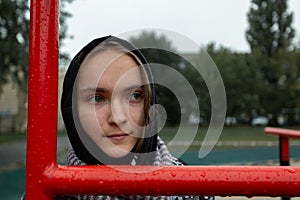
[61,36,157,164]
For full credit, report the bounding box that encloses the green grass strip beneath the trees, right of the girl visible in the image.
[159,126,300,151]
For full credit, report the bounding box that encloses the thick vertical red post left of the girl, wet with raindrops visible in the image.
[26,0,59,200]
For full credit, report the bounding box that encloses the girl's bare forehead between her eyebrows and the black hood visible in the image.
[78,51,142,90]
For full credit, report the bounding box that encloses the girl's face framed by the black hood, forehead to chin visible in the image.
[77,50,145,158]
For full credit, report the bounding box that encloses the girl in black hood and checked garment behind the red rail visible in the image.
[61,36,212,199]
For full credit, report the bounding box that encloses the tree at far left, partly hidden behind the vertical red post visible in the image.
[0,0,73,131]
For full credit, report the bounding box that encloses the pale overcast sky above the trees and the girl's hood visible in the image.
[64,0,300,57]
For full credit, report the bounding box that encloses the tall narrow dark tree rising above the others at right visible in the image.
[246,0,295,125]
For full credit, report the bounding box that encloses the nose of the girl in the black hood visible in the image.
[108,100,127,126]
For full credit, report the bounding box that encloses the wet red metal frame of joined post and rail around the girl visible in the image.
[26,0,300,200]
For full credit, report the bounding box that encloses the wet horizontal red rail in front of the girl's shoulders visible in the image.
[43,165,300,197]
